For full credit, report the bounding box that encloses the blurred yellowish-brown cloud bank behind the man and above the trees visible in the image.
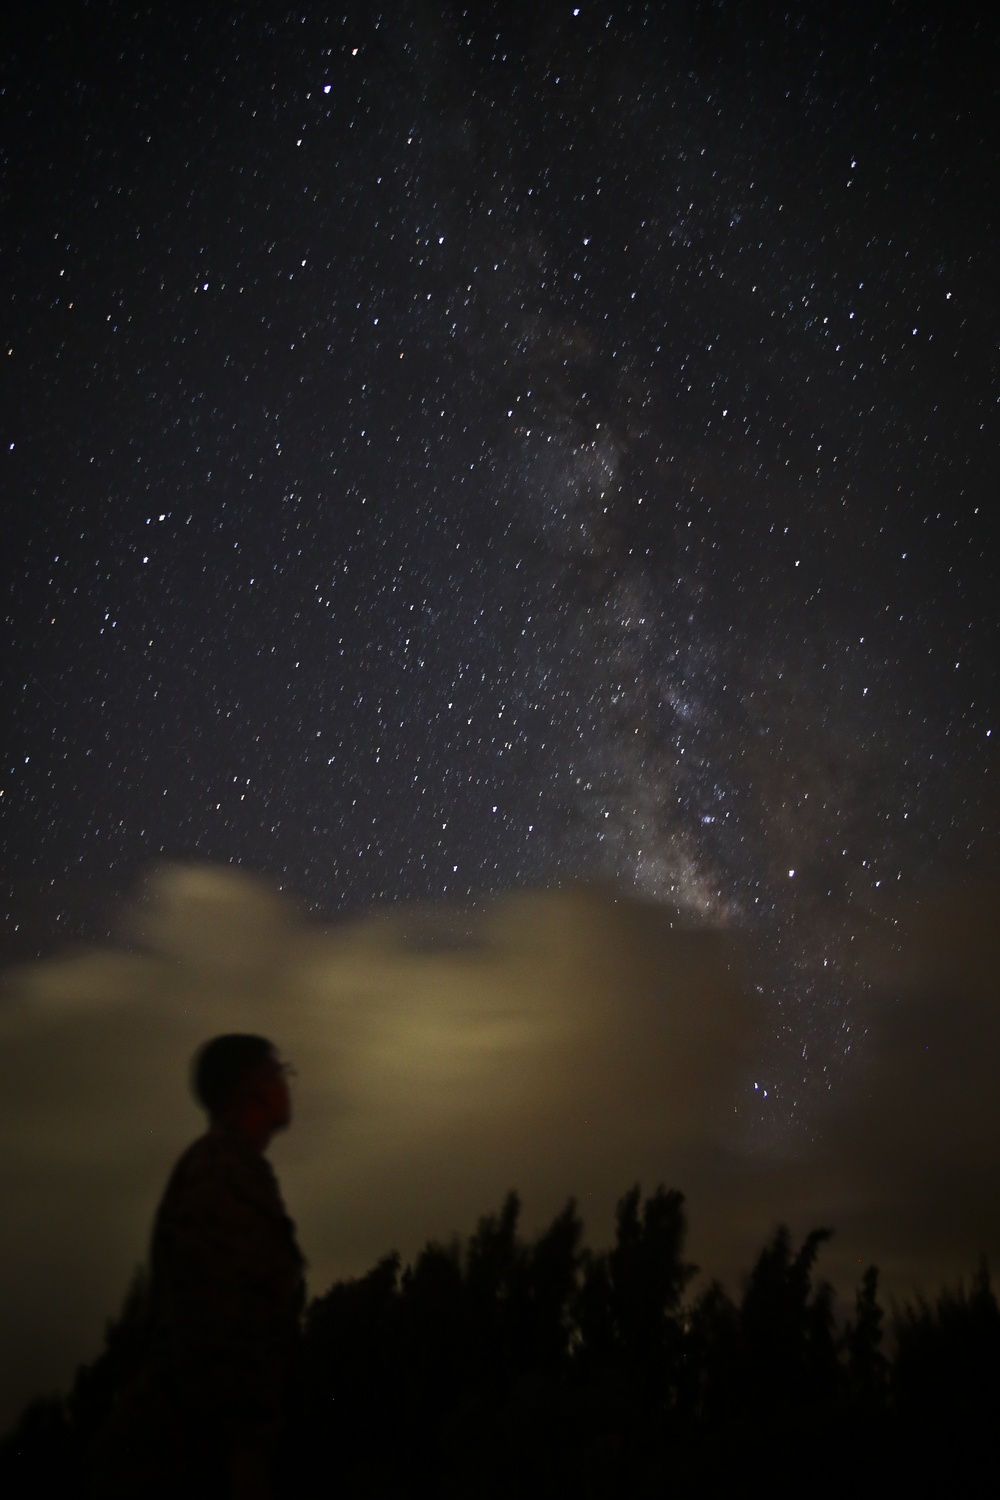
[0,867,1000,1422]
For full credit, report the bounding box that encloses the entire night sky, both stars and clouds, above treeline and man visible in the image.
[0,0,1000,1421]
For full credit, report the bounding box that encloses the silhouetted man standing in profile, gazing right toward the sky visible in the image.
[94,1034,304,1500]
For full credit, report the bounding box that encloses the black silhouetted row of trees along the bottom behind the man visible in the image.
[0,1187,1000,1500]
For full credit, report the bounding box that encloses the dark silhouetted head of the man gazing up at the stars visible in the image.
[192,1032,291,1143]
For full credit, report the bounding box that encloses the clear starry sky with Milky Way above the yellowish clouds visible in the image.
[0,0,1000,1125]
